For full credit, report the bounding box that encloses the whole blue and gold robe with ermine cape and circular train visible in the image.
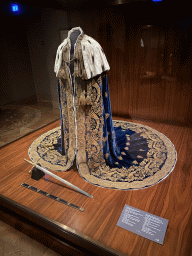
[29,27,176,190]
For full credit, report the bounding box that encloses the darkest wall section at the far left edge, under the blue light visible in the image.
[0,5,36,105]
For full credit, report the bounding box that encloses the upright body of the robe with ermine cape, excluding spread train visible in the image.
[54,27,134,177]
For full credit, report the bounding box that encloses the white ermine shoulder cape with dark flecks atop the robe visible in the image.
[54,27,110,79]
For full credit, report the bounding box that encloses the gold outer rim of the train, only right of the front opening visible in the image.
[79,121,177,190]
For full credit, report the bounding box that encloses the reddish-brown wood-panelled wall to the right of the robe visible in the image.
[69,4,192,124]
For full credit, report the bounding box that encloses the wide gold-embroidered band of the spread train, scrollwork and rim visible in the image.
[29,121,176,189]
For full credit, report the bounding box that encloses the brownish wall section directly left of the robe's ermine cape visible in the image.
[27,8,68,108]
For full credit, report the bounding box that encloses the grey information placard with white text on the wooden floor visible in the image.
[117,205,168,244]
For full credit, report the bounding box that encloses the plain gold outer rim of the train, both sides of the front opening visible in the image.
[29,121,177,190]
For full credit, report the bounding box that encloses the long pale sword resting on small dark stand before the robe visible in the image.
[24,158,93,198]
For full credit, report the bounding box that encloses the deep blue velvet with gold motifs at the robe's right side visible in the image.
[101,75,149,168]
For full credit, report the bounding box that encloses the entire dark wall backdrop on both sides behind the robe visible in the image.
[0,0,192,125]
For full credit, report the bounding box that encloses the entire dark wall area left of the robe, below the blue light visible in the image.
[0,0,68,108]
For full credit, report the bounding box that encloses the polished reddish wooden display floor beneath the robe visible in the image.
[0,118,192,256]
